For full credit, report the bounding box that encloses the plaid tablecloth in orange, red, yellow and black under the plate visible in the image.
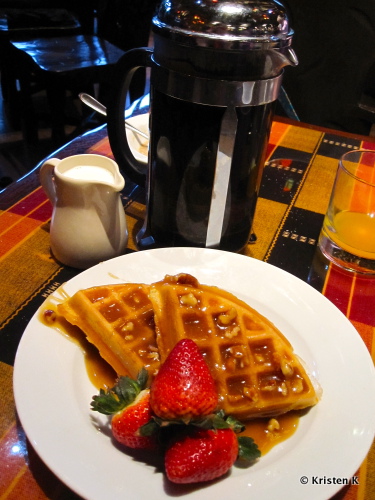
[0,120,375,500]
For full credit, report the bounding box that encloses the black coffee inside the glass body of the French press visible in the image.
[138,90,273,251]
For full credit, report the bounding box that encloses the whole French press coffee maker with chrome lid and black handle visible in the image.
[108,0,297,251]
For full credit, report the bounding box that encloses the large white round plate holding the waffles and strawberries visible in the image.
[14,248,375,500]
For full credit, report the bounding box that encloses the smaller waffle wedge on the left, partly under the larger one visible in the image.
[58,283,159,378]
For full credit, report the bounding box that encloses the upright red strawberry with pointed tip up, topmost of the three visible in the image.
[150,339,218,423]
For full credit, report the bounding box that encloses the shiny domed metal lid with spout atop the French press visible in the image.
[152,0,297,80]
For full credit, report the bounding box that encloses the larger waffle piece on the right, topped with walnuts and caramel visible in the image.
[149,274,319,419]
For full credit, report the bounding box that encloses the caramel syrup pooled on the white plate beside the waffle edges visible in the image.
[39,299,301,455]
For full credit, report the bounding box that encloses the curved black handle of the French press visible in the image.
[107,47,153,186]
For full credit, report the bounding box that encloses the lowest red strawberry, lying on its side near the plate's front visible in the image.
[165,429,238,483]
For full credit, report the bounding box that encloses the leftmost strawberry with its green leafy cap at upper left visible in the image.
[91,370,157,449]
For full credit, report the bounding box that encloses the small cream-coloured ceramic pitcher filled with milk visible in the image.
[40,154,128,269]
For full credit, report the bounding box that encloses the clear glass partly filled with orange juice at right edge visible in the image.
[319,149,375,274]
